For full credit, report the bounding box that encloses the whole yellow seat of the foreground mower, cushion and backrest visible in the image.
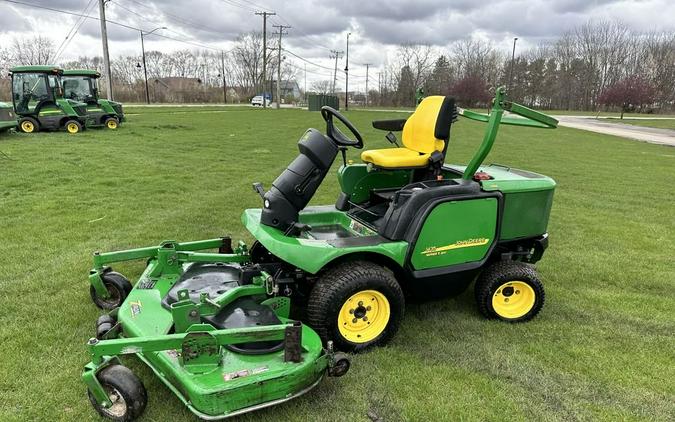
[361,95,455,169]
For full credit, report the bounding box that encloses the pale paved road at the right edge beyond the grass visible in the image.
[553,116,675,146]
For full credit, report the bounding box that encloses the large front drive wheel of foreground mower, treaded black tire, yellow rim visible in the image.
[307,261,405,352]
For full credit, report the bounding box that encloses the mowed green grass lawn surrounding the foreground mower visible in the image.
[0,108,675,421]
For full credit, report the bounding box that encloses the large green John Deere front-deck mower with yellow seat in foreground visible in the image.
[83,85,557,420]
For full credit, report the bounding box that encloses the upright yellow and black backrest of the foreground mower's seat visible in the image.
[403,95,455,154]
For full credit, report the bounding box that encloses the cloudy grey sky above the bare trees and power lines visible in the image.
[0,0,675,89]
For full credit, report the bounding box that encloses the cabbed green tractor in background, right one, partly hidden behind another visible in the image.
[61,69,124,129]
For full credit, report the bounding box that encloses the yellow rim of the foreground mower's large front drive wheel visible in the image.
[338,290,391,343]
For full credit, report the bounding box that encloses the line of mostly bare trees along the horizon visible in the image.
[0,21,675,112]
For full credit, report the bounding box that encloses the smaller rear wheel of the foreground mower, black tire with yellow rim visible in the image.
[475,261,545,322]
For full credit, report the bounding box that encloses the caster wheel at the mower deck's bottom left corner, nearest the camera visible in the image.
[87,365,148,422]
